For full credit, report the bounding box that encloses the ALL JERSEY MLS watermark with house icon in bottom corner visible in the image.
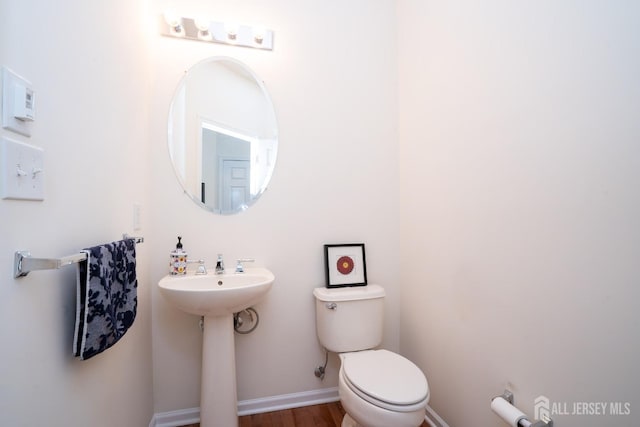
[533,396,631,422]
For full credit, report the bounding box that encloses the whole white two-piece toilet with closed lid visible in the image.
[313,285,429,427]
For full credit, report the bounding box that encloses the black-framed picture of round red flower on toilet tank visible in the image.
[324,243,367,288]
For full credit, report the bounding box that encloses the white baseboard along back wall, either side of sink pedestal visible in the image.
[149,387,340,427]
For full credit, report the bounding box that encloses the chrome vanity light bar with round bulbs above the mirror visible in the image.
[160,12,273,50]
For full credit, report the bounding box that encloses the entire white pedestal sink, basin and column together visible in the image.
[158,268,275,427]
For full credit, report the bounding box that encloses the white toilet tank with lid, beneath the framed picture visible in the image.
[313,285,385,353]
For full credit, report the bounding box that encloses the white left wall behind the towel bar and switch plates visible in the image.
[0,0,152,427]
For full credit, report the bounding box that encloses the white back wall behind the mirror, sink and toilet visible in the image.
[149,0,399,412]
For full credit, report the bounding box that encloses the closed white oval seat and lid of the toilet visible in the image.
[341,350,429,412]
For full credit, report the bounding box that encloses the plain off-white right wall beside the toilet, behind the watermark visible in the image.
[398,0,640,426]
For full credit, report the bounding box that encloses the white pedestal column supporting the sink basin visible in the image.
[200,314,238,427]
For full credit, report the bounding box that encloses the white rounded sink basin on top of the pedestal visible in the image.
[158,268,275,316]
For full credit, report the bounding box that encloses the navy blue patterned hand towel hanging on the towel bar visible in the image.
[73,239,138,360]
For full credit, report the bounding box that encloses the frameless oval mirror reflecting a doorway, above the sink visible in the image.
[168,57,278,214]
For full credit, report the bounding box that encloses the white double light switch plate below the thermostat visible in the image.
[0,138,44,200]
